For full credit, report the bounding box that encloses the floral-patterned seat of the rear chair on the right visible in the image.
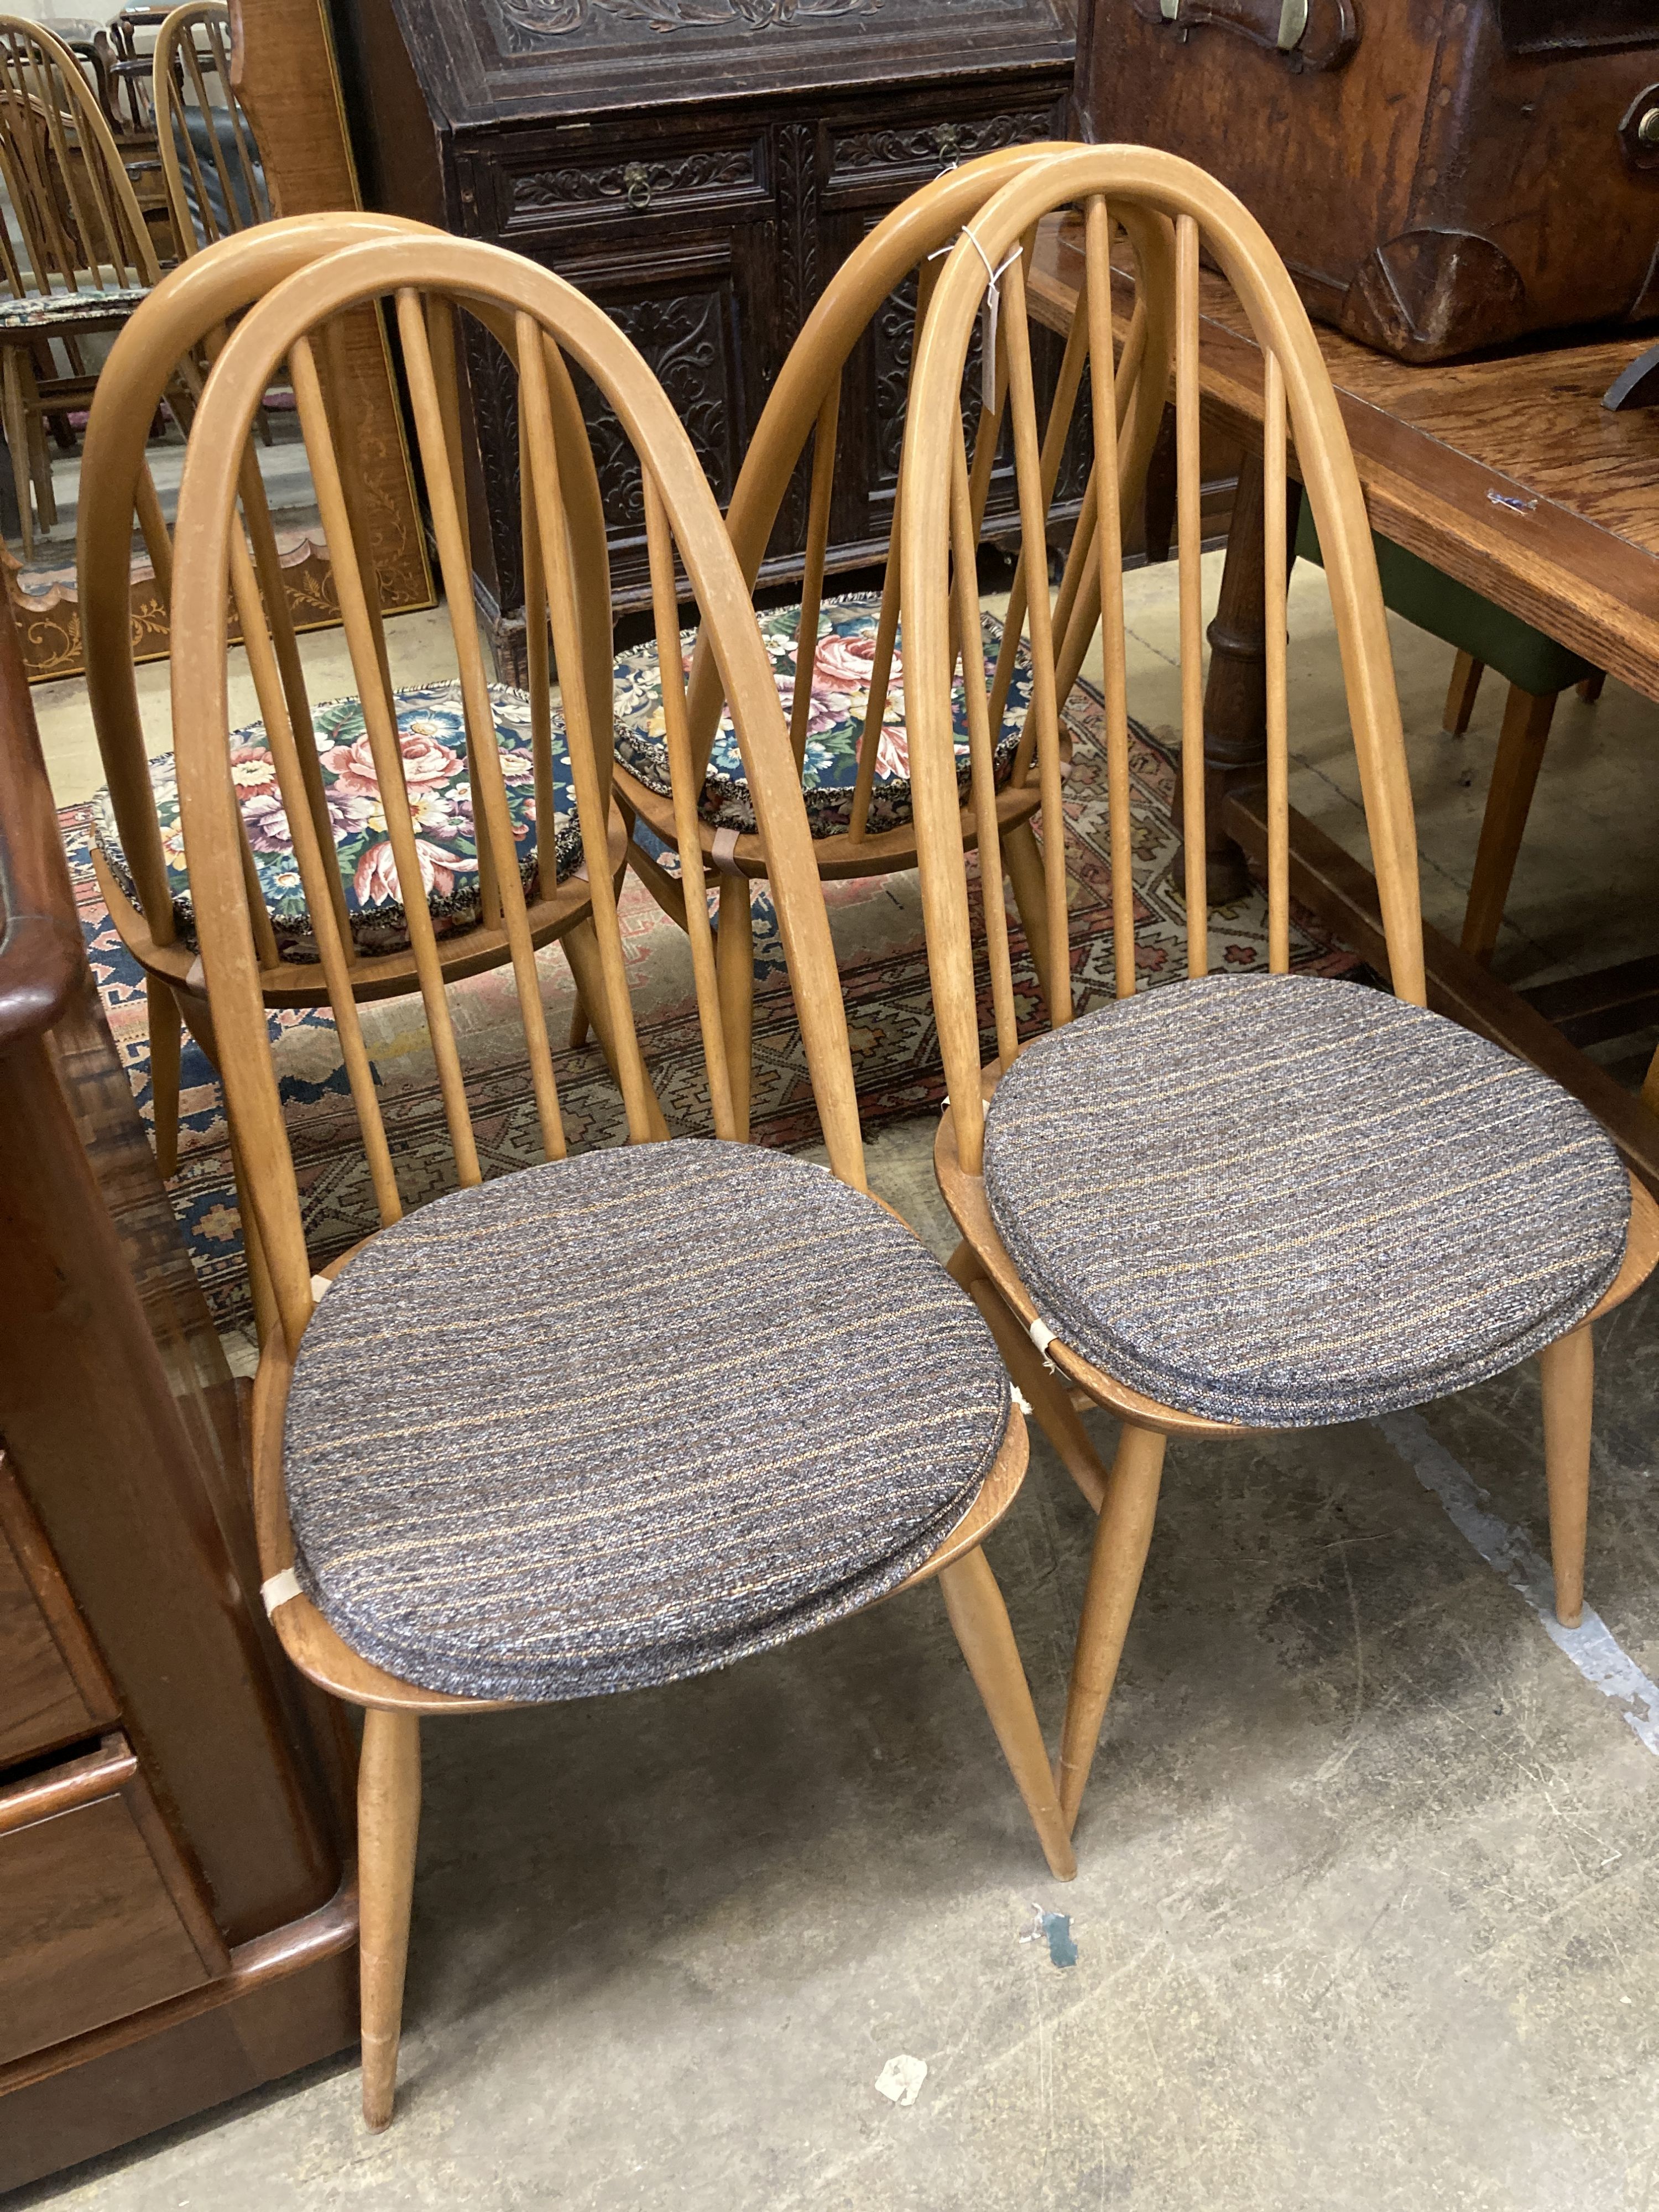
[613,593,1033,838]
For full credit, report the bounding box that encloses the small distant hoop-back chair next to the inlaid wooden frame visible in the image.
[155,0,272,254]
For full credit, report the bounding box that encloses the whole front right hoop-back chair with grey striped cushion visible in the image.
[900,146,1659,1823]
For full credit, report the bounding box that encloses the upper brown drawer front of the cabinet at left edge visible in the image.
[0,1453,115,1770]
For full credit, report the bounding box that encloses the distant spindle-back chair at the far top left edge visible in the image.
[0,15,161,560]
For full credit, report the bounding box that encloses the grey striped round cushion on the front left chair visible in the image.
[285,1141,1009,1699]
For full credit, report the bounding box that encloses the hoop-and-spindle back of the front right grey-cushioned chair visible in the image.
[900,146,1425,1172]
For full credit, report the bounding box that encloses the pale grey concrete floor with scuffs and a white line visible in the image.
[15,571,1659,2212]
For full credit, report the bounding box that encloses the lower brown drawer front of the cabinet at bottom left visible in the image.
[0,1736,228,2062]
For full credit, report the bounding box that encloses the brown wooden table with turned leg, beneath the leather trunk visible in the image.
[1029,219,1659,1192]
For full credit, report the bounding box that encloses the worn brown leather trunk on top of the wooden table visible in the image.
[1077,0,1659,361]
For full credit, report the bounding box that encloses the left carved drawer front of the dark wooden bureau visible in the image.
[495,137,770,239]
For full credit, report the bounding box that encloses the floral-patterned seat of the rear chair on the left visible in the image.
[93,681,582,960]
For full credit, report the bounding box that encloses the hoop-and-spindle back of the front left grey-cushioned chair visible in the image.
[173,237,863,1345]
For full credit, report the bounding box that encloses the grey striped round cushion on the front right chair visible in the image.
[984,975,1630,1427]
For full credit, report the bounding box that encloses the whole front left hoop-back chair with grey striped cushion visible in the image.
[173,225,1075,2126]
